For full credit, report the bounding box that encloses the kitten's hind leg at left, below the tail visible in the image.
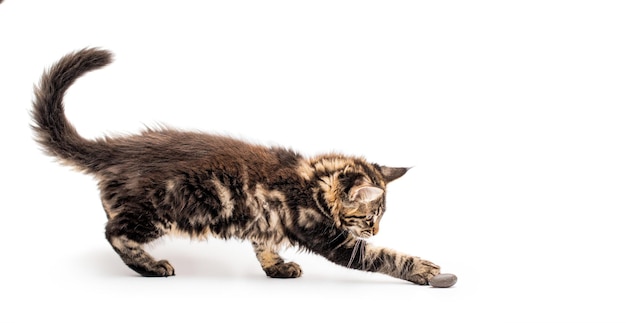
[106,213,174,277]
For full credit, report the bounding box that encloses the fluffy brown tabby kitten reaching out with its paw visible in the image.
[32,48,439,284]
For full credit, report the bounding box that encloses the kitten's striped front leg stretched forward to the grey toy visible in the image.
[323,236,440,285]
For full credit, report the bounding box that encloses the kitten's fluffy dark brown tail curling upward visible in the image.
[32,48,113,171]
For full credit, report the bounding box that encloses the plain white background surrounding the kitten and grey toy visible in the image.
[0,0,626,322]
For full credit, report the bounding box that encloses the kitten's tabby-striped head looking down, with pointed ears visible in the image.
[314,156,408,238]
